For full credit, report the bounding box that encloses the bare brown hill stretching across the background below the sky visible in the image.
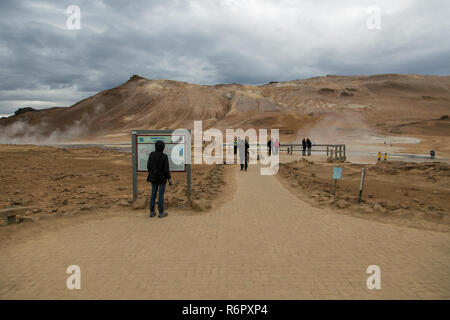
[0,74,450,143]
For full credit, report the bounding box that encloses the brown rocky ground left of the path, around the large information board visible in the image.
[0,145,227,226]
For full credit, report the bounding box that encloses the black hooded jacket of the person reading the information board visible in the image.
[147,140,171,184]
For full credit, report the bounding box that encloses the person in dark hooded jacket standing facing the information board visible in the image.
[147,140,172,218]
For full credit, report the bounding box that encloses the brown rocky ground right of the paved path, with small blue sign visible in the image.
[277,159,450,232]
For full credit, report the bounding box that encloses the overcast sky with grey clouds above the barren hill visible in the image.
[0,0,450,115]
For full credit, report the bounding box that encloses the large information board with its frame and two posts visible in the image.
[131,129,191,205]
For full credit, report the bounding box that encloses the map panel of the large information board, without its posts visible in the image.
[136,134,187,172]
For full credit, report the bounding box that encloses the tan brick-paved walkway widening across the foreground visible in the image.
[0,167,450,299]
